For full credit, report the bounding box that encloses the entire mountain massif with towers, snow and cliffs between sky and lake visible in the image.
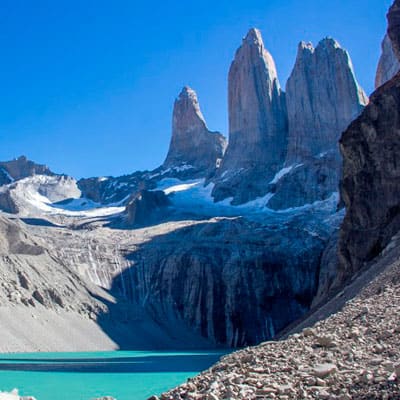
[0,7,400,351]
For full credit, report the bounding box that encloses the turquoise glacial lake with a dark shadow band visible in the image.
[0,351,226,400]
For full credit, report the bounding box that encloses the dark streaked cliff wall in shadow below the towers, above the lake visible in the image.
[119,219,327,347]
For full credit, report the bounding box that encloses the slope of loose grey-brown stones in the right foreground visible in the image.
[161,236,400,400]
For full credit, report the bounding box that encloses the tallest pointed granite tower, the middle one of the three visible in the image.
[213,29,287,203]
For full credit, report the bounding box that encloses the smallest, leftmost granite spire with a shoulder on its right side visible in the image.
[163,87,226,172]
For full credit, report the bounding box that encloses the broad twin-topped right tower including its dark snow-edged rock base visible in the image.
[268,39,368,209]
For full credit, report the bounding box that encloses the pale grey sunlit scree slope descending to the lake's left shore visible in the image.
[0,216,117,351]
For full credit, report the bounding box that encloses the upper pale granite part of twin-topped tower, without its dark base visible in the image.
[286,38,368,165]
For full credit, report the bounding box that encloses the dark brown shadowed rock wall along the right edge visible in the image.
[338,1,400,282]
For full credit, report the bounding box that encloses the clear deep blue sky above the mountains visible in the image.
[0,0,392,178]
